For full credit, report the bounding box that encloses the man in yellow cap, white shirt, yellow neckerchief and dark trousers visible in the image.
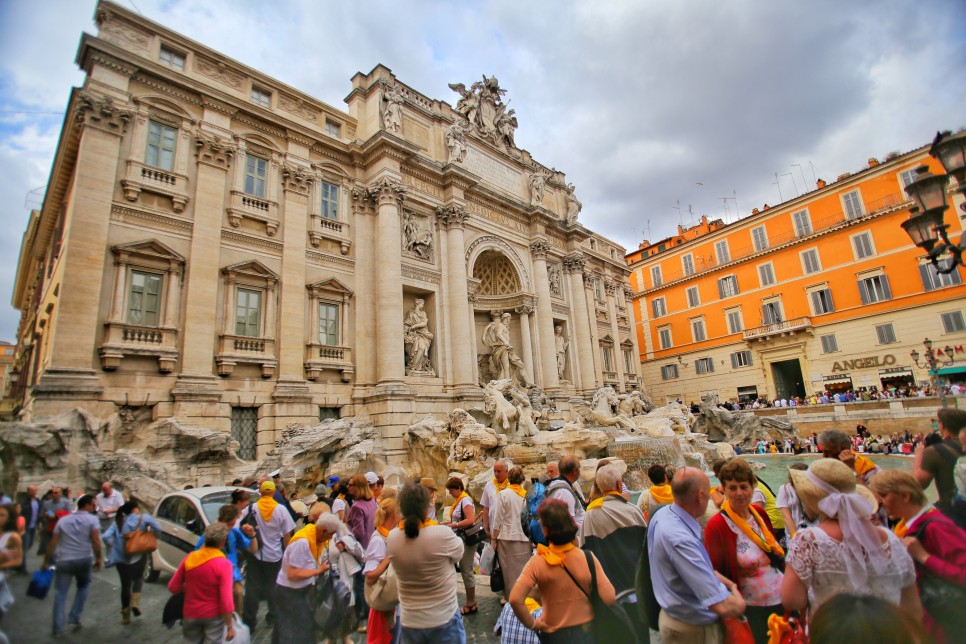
[242,479,295,634]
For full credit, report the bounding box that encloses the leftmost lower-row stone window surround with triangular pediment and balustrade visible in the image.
[99,239,186,373]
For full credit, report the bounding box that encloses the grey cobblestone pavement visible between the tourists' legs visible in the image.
[0,556,659,644]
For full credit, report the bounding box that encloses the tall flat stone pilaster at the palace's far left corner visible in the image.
[32,89,134,408]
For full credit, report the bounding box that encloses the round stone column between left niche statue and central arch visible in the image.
[436,204,474,388]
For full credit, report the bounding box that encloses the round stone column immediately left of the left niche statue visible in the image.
[372,177,406,384]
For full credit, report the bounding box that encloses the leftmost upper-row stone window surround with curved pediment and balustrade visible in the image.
[121,95,195,213]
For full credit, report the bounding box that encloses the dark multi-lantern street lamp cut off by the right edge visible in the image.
[902,131,966,274]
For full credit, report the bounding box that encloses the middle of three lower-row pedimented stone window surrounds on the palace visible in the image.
[215,260,279,378]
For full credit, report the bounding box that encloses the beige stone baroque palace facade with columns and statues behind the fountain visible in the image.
[14,1,641,459]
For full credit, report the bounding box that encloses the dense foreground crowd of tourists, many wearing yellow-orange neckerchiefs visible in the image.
[0,409,966,644]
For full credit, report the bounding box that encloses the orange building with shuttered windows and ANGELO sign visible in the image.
[627,146,966,403]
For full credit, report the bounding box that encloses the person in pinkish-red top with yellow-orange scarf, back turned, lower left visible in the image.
[168,523,235,642]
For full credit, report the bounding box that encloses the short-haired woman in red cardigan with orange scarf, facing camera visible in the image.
[704,458,785,643]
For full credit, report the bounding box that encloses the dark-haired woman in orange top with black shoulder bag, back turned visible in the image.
[510,499,617,644]
